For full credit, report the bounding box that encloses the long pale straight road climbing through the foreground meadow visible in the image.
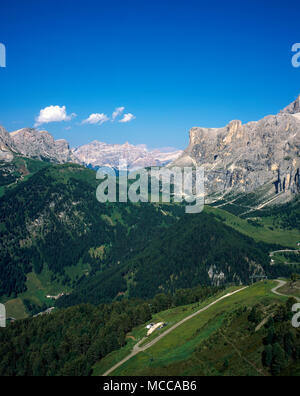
[102,286,248,377]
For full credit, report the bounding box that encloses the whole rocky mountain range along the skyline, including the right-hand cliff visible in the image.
[0,95,300,205]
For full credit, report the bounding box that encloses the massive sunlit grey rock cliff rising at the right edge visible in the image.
[172,97,300,201]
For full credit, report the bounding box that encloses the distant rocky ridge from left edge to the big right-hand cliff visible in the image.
[0,127,182,169]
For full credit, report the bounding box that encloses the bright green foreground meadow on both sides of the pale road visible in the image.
[93,281,285,376]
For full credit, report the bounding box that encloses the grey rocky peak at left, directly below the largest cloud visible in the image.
[10,128,78,163]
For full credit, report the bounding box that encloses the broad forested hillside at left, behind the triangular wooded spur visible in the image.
[0,164,183,296]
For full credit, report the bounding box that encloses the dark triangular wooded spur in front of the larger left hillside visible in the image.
[58,212,292,307]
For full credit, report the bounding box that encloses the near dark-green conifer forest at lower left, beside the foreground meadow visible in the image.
[0,287,220,376]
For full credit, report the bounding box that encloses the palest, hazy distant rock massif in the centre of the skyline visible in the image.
[73,141,182,169]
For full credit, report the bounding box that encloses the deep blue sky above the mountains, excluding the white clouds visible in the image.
[0,0,300,148]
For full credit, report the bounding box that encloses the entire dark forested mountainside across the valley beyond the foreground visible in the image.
[0,158,299,317]
